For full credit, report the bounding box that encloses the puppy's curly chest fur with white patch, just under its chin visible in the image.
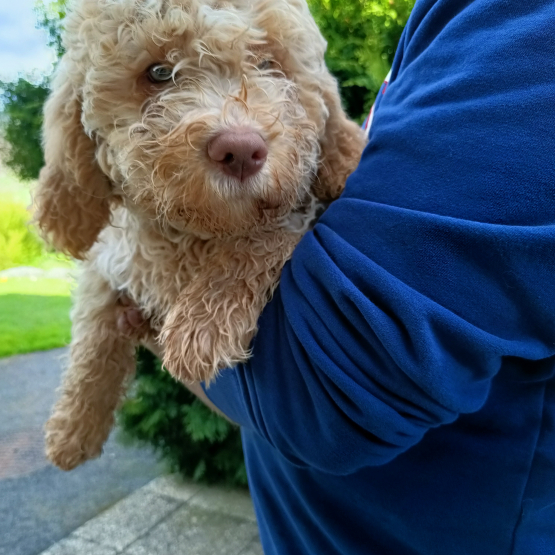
[91,199,321,329]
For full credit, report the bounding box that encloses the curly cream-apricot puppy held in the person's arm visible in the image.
[36,0,364,469]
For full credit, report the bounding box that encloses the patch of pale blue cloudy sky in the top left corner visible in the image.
[0,0,55,81]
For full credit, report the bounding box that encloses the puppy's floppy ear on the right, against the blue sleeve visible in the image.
[314,81,366,200]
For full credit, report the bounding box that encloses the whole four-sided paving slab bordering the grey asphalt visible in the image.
[75,489,180,551]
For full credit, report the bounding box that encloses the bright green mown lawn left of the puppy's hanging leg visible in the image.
[0,278,71,357]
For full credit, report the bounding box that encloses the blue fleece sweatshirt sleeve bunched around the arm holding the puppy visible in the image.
[207,0,555,474]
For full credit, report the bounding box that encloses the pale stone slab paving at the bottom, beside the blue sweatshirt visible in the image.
[42,476,263,555]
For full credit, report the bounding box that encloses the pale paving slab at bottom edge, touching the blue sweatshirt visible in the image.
[122,504,257,555]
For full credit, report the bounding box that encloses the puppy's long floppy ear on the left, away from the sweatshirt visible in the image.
[35,65,111,258]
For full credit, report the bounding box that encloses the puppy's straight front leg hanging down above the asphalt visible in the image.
[45,266,137,470]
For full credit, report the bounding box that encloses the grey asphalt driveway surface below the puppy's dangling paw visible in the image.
[0,349,163,555]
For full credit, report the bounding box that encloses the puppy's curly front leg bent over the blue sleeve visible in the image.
[161,231,300,382]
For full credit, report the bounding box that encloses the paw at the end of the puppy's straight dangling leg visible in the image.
[45,413,107,470]
